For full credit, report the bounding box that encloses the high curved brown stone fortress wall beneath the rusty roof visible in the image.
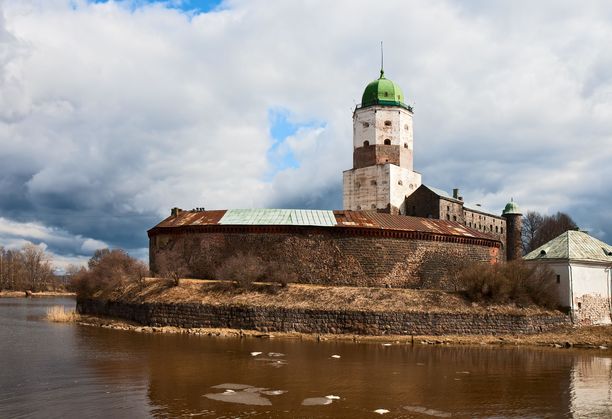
[149,226,503,290]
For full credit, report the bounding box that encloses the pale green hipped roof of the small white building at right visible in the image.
[524,230,612,264]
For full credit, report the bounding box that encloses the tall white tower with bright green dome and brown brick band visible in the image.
[343,69,421,214]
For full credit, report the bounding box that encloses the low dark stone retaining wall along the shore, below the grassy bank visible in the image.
[77,299,571,335]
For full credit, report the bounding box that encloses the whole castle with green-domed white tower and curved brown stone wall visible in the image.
[148,70,521,289]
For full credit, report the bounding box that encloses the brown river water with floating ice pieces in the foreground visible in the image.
[0,299,612,418]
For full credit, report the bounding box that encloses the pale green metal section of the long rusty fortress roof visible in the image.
[219,209,337,227]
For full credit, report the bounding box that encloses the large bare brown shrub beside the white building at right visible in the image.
[457,260,557,308]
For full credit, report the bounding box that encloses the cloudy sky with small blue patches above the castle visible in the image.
[0,0,612,269]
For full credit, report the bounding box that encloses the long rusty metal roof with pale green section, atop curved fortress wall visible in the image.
[148,209,499,241]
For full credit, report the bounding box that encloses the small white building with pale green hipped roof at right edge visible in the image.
[524,230,612,324]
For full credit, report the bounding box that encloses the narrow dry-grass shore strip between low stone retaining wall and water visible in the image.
[76,315,612,350]
